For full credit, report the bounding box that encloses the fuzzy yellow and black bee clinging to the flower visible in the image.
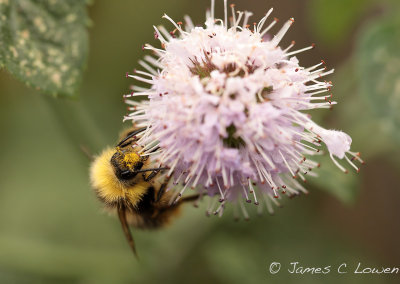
[90,127,199,257]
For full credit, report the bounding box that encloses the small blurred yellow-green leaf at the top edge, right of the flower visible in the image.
[309,0,372,48]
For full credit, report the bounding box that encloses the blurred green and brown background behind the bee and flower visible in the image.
[0,0,400,283]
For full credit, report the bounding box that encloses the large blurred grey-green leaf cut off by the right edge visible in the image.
[357,15,400,141]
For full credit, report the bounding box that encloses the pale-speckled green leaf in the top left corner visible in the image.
[0,0,88,96]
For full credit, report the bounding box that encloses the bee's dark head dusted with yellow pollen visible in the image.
[111,146,144,180]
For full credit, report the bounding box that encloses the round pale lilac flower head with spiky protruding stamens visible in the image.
[125,0,362,216]
